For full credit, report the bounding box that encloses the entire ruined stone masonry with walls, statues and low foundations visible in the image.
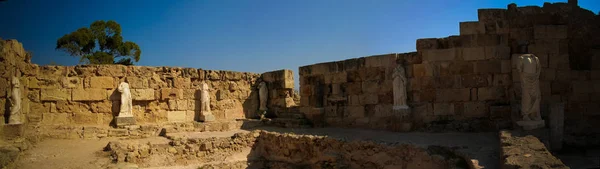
[0,0,600,168]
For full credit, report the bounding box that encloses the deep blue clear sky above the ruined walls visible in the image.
[0,0,600,74]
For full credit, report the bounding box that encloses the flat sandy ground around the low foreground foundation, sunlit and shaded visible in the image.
[15,127,499,169]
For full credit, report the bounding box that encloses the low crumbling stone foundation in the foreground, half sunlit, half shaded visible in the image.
[106,130,472,169]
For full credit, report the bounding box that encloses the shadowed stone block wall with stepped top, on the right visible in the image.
[299,1,600,137]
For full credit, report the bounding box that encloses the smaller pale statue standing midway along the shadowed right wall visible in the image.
[392,65,409,110]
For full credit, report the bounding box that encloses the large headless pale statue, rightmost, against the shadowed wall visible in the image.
[517,54,542,121]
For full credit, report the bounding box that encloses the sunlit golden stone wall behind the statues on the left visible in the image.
[0,40,270,131]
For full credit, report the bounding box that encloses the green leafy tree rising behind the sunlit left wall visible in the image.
[56,20,142,65]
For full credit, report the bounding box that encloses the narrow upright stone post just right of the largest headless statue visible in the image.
[548,103,565,151]
